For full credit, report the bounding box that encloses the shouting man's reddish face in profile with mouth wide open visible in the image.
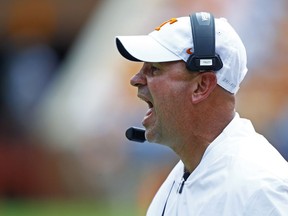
[130,61,196,145]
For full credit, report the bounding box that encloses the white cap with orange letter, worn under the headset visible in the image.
[116,13,247,94]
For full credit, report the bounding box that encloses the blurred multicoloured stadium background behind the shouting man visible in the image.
[0,0,288,216]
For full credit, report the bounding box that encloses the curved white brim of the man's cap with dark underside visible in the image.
[116,35,180,62]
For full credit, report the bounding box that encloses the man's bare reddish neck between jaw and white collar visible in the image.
[173,87,235,173]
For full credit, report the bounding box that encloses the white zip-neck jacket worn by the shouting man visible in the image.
[147,114,288,216]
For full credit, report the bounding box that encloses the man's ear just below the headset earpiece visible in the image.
[191,71,217,104]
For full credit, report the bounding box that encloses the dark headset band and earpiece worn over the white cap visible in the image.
[186,12,223,71]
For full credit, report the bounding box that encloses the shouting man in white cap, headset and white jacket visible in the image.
[116,13,288,216]
